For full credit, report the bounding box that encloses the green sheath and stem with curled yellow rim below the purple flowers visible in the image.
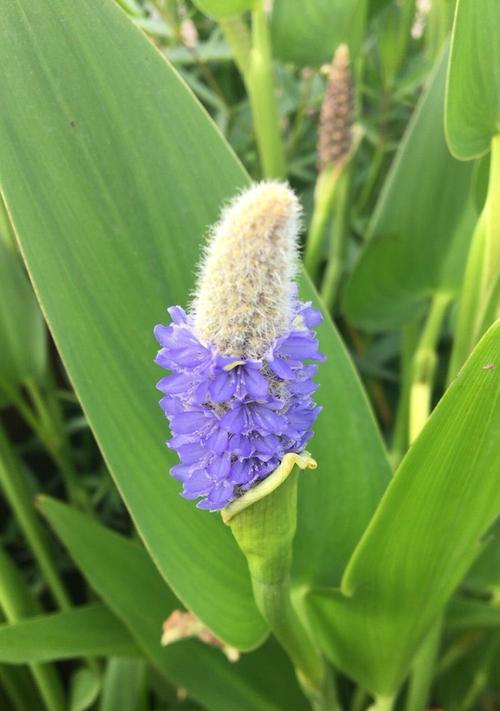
[225,452,337,711]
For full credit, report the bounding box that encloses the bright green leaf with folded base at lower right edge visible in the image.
[310,323,500,695]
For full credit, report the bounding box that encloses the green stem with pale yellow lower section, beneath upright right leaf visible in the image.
[408,292,451,443]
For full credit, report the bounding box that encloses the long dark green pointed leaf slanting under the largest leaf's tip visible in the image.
[40,497,302,711]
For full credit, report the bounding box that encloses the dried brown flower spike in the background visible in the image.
[318,44,354,173]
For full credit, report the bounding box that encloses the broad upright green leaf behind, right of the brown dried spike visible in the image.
[344,52,475,330]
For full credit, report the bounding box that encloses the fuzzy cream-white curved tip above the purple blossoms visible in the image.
[191,182,300,358]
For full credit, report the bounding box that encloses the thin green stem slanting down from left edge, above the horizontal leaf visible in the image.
[0,426,71,610]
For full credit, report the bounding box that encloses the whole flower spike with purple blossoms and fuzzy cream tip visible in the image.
[155,182,323,511]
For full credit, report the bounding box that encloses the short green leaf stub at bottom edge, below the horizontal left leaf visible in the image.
[99,658,147,711]
